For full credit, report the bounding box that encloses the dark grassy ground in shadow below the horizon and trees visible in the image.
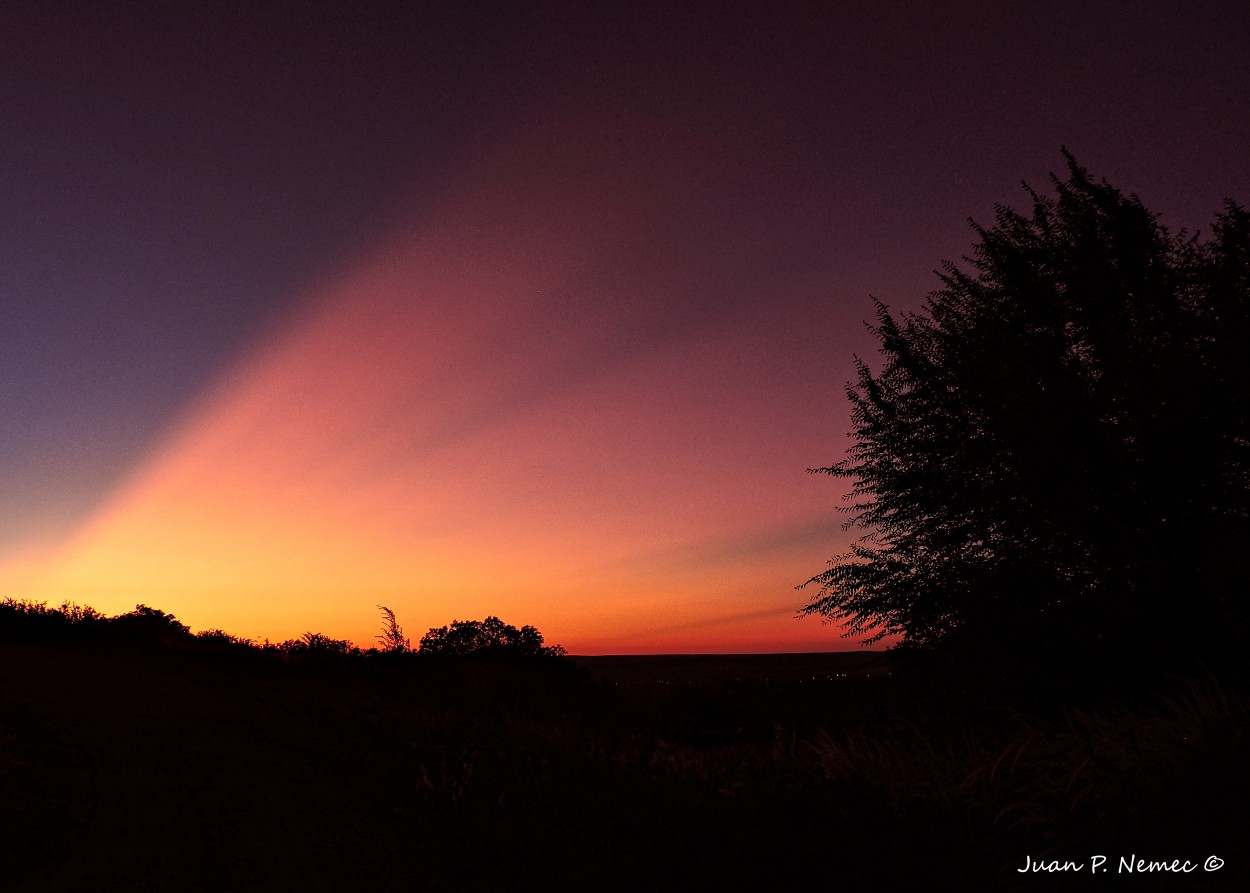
[0,605,1250,890]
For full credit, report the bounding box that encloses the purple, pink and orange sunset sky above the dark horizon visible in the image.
[0,0,1250,654]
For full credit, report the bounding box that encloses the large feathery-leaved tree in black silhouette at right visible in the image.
[804,153,1250,680]
